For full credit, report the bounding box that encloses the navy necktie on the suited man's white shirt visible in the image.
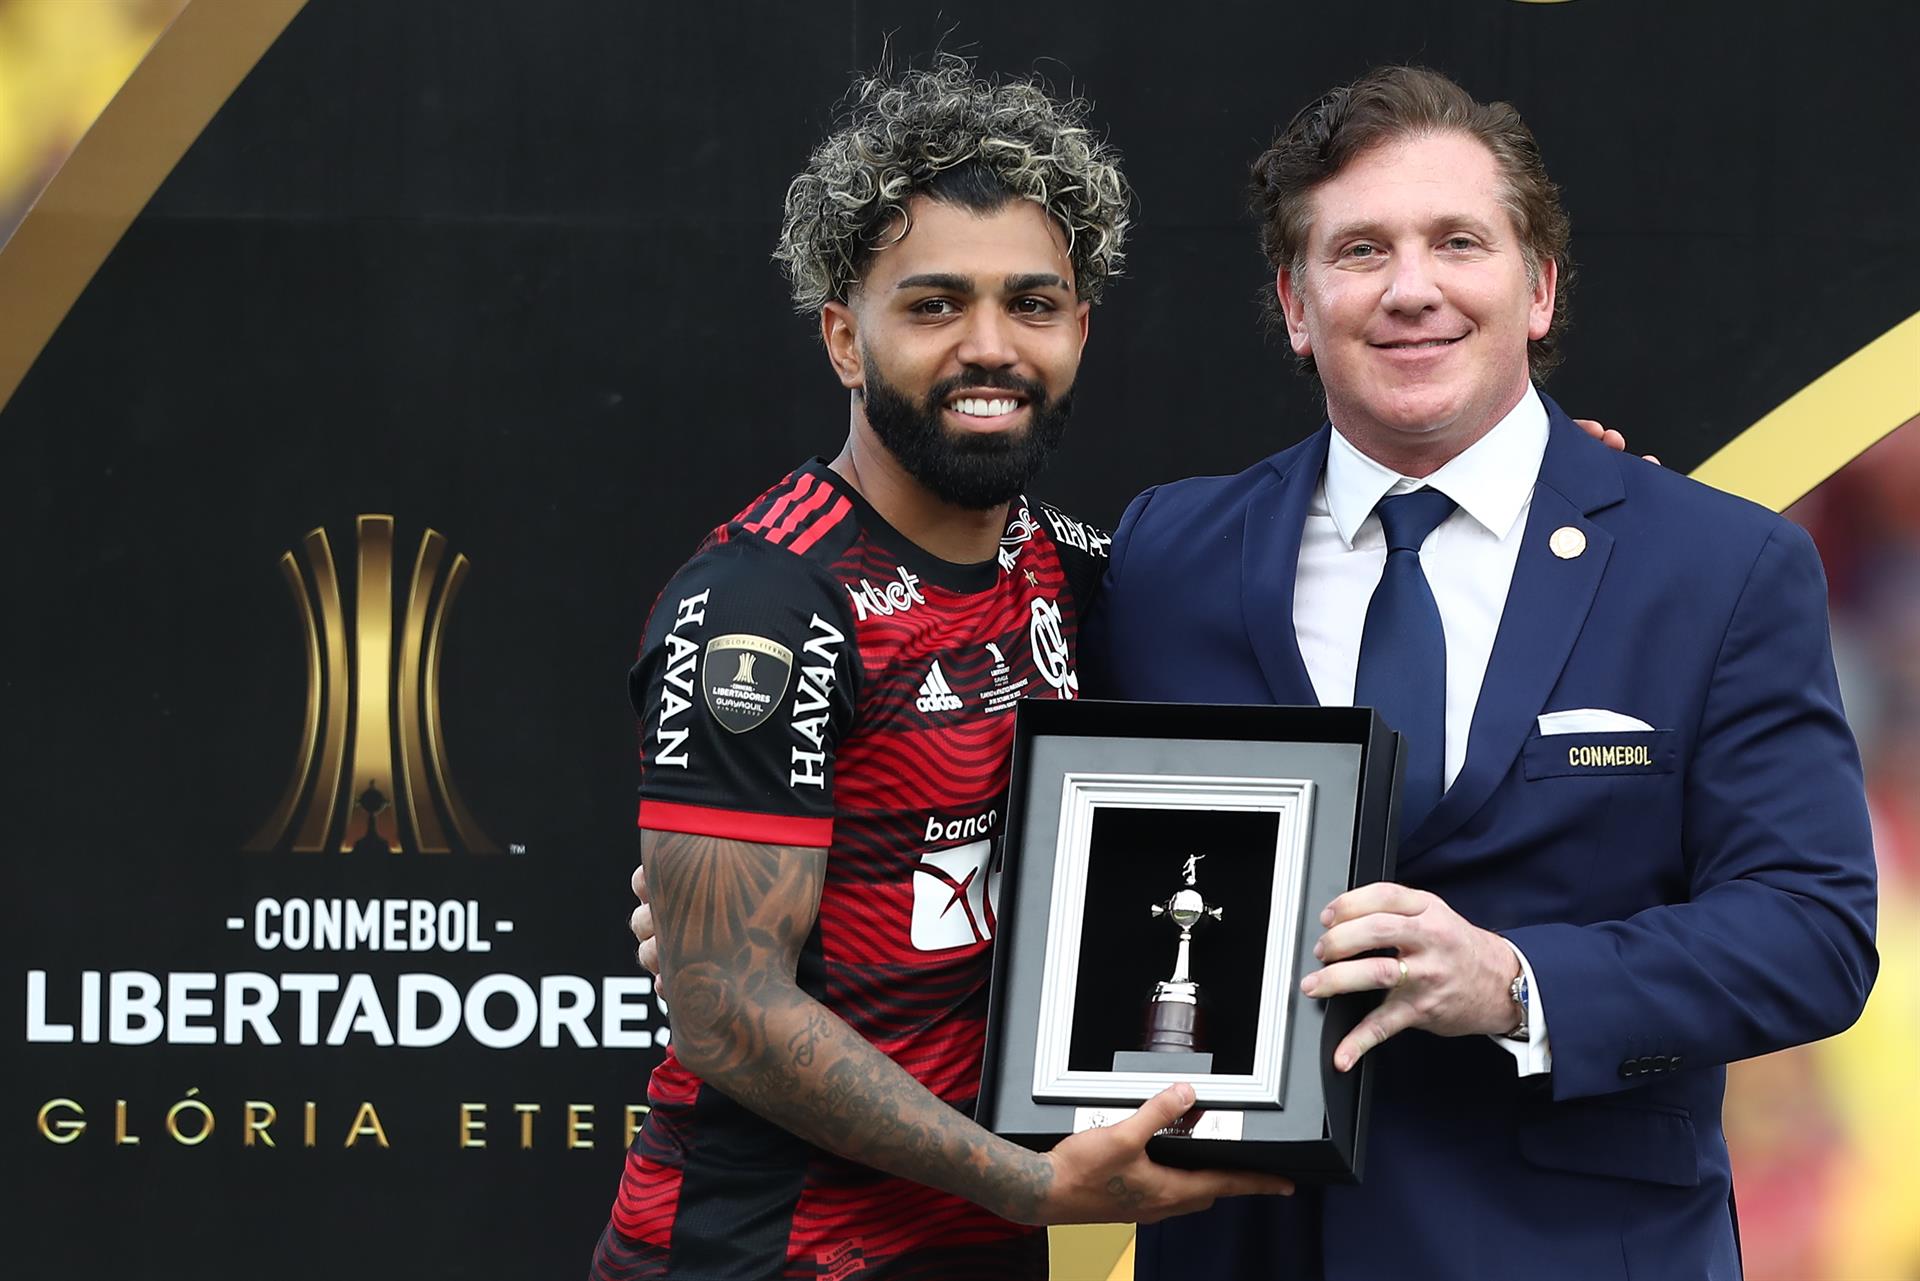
[1354,490,1453,837]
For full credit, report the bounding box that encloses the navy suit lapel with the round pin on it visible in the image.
[1400,398,1626,862]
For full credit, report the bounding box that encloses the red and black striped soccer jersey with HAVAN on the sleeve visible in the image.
[593,459,1108,1281]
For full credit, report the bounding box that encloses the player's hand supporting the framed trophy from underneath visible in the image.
[1039,1083,1294,1223]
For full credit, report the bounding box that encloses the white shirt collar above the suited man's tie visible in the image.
[1325,382,1548,547]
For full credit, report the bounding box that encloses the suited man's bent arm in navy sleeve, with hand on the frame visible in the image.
[1302,522,1878,1099]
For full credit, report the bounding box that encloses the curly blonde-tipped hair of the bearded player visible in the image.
[774,54,1133,313]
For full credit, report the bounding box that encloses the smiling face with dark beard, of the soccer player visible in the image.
[822,196,1089,511]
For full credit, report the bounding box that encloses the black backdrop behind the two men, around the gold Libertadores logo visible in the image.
[0,0,1920,1277]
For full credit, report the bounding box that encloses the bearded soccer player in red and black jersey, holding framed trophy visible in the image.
[593,58,1290,1281]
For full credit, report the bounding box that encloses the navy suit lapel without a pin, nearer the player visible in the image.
[1240,426,1332,707]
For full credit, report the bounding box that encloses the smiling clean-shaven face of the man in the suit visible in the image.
[1277,133,1557,476]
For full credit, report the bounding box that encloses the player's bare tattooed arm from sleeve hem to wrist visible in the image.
[641,832,1052,1221]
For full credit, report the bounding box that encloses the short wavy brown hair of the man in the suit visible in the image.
[1248,67,1574,380]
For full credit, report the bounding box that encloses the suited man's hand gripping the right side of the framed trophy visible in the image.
[1300,882,1521,1072]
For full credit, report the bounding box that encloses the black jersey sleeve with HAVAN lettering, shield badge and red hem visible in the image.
[628,540,858,847]
